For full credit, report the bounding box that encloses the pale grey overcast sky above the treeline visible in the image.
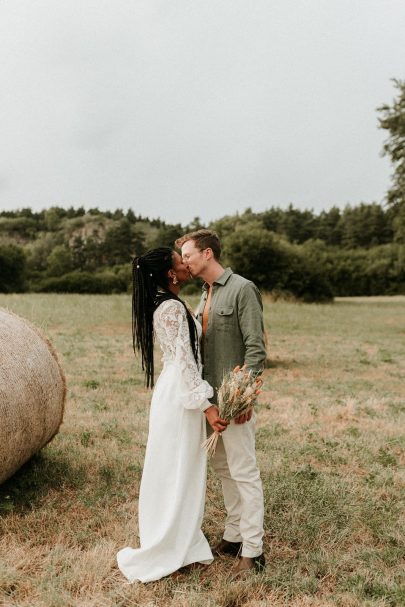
[0,0,405,224]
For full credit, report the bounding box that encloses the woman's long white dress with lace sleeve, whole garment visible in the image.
[117,299,213,582]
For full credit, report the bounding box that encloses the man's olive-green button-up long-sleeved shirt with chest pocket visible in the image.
[197,268,266,402]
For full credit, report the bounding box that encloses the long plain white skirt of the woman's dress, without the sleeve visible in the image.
[117,363,213,582]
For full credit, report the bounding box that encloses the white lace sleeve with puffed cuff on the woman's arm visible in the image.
[157,299,214,411]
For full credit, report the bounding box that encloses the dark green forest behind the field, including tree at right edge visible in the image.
[0,81,405,301]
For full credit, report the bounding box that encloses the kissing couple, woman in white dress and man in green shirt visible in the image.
[117,229,266,582]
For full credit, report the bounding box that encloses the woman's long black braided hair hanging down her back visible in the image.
[132,247,198,388]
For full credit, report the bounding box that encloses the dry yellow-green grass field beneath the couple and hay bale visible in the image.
[0,295,405,607]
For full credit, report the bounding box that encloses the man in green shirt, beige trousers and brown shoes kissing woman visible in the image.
[176,229,266,577]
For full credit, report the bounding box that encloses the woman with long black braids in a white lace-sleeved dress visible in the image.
[117,247,218,582]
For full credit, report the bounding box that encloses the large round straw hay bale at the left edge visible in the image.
[0,308,66,483]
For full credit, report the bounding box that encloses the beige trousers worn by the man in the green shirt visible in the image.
[211,415,264,558]
